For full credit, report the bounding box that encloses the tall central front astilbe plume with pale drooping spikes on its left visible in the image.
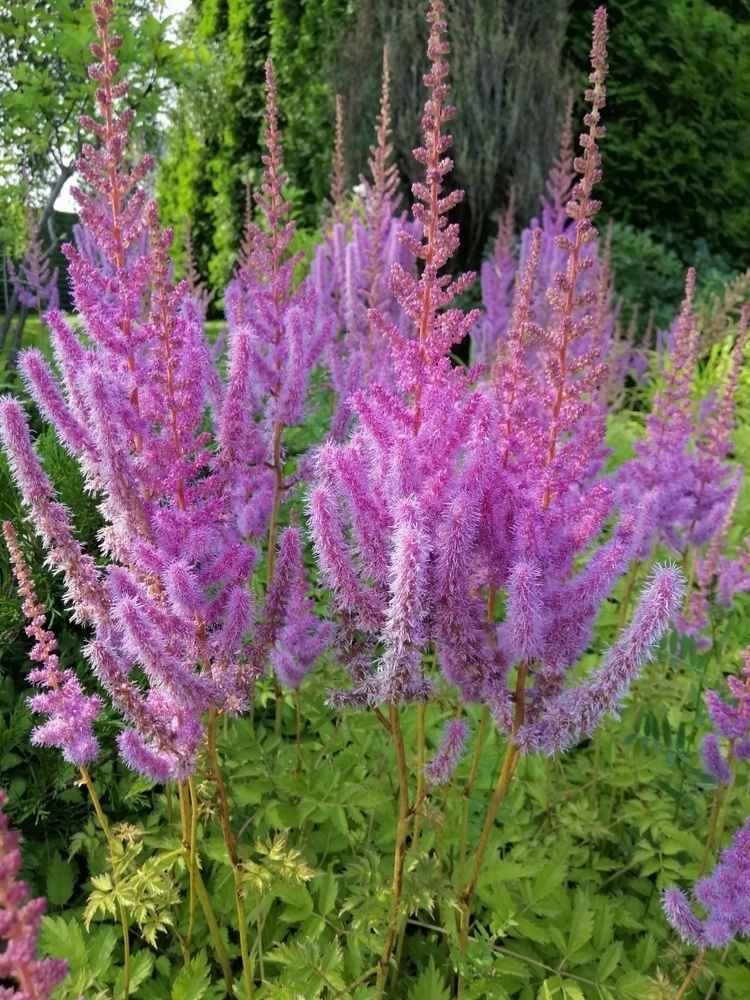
[309,0,493,704]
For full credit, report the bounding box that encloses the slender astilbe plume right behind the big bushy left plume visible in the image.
[225,60,333,544]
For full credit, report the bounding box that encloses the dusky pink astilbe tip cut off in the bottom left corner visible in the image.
[0,790,68,1000]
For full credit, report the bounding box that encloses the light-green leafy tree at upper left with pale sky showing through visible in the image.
[0,0,181,342]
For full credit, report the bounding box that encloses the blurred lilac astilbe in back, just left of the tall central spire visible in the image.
[308,47,415,440]
